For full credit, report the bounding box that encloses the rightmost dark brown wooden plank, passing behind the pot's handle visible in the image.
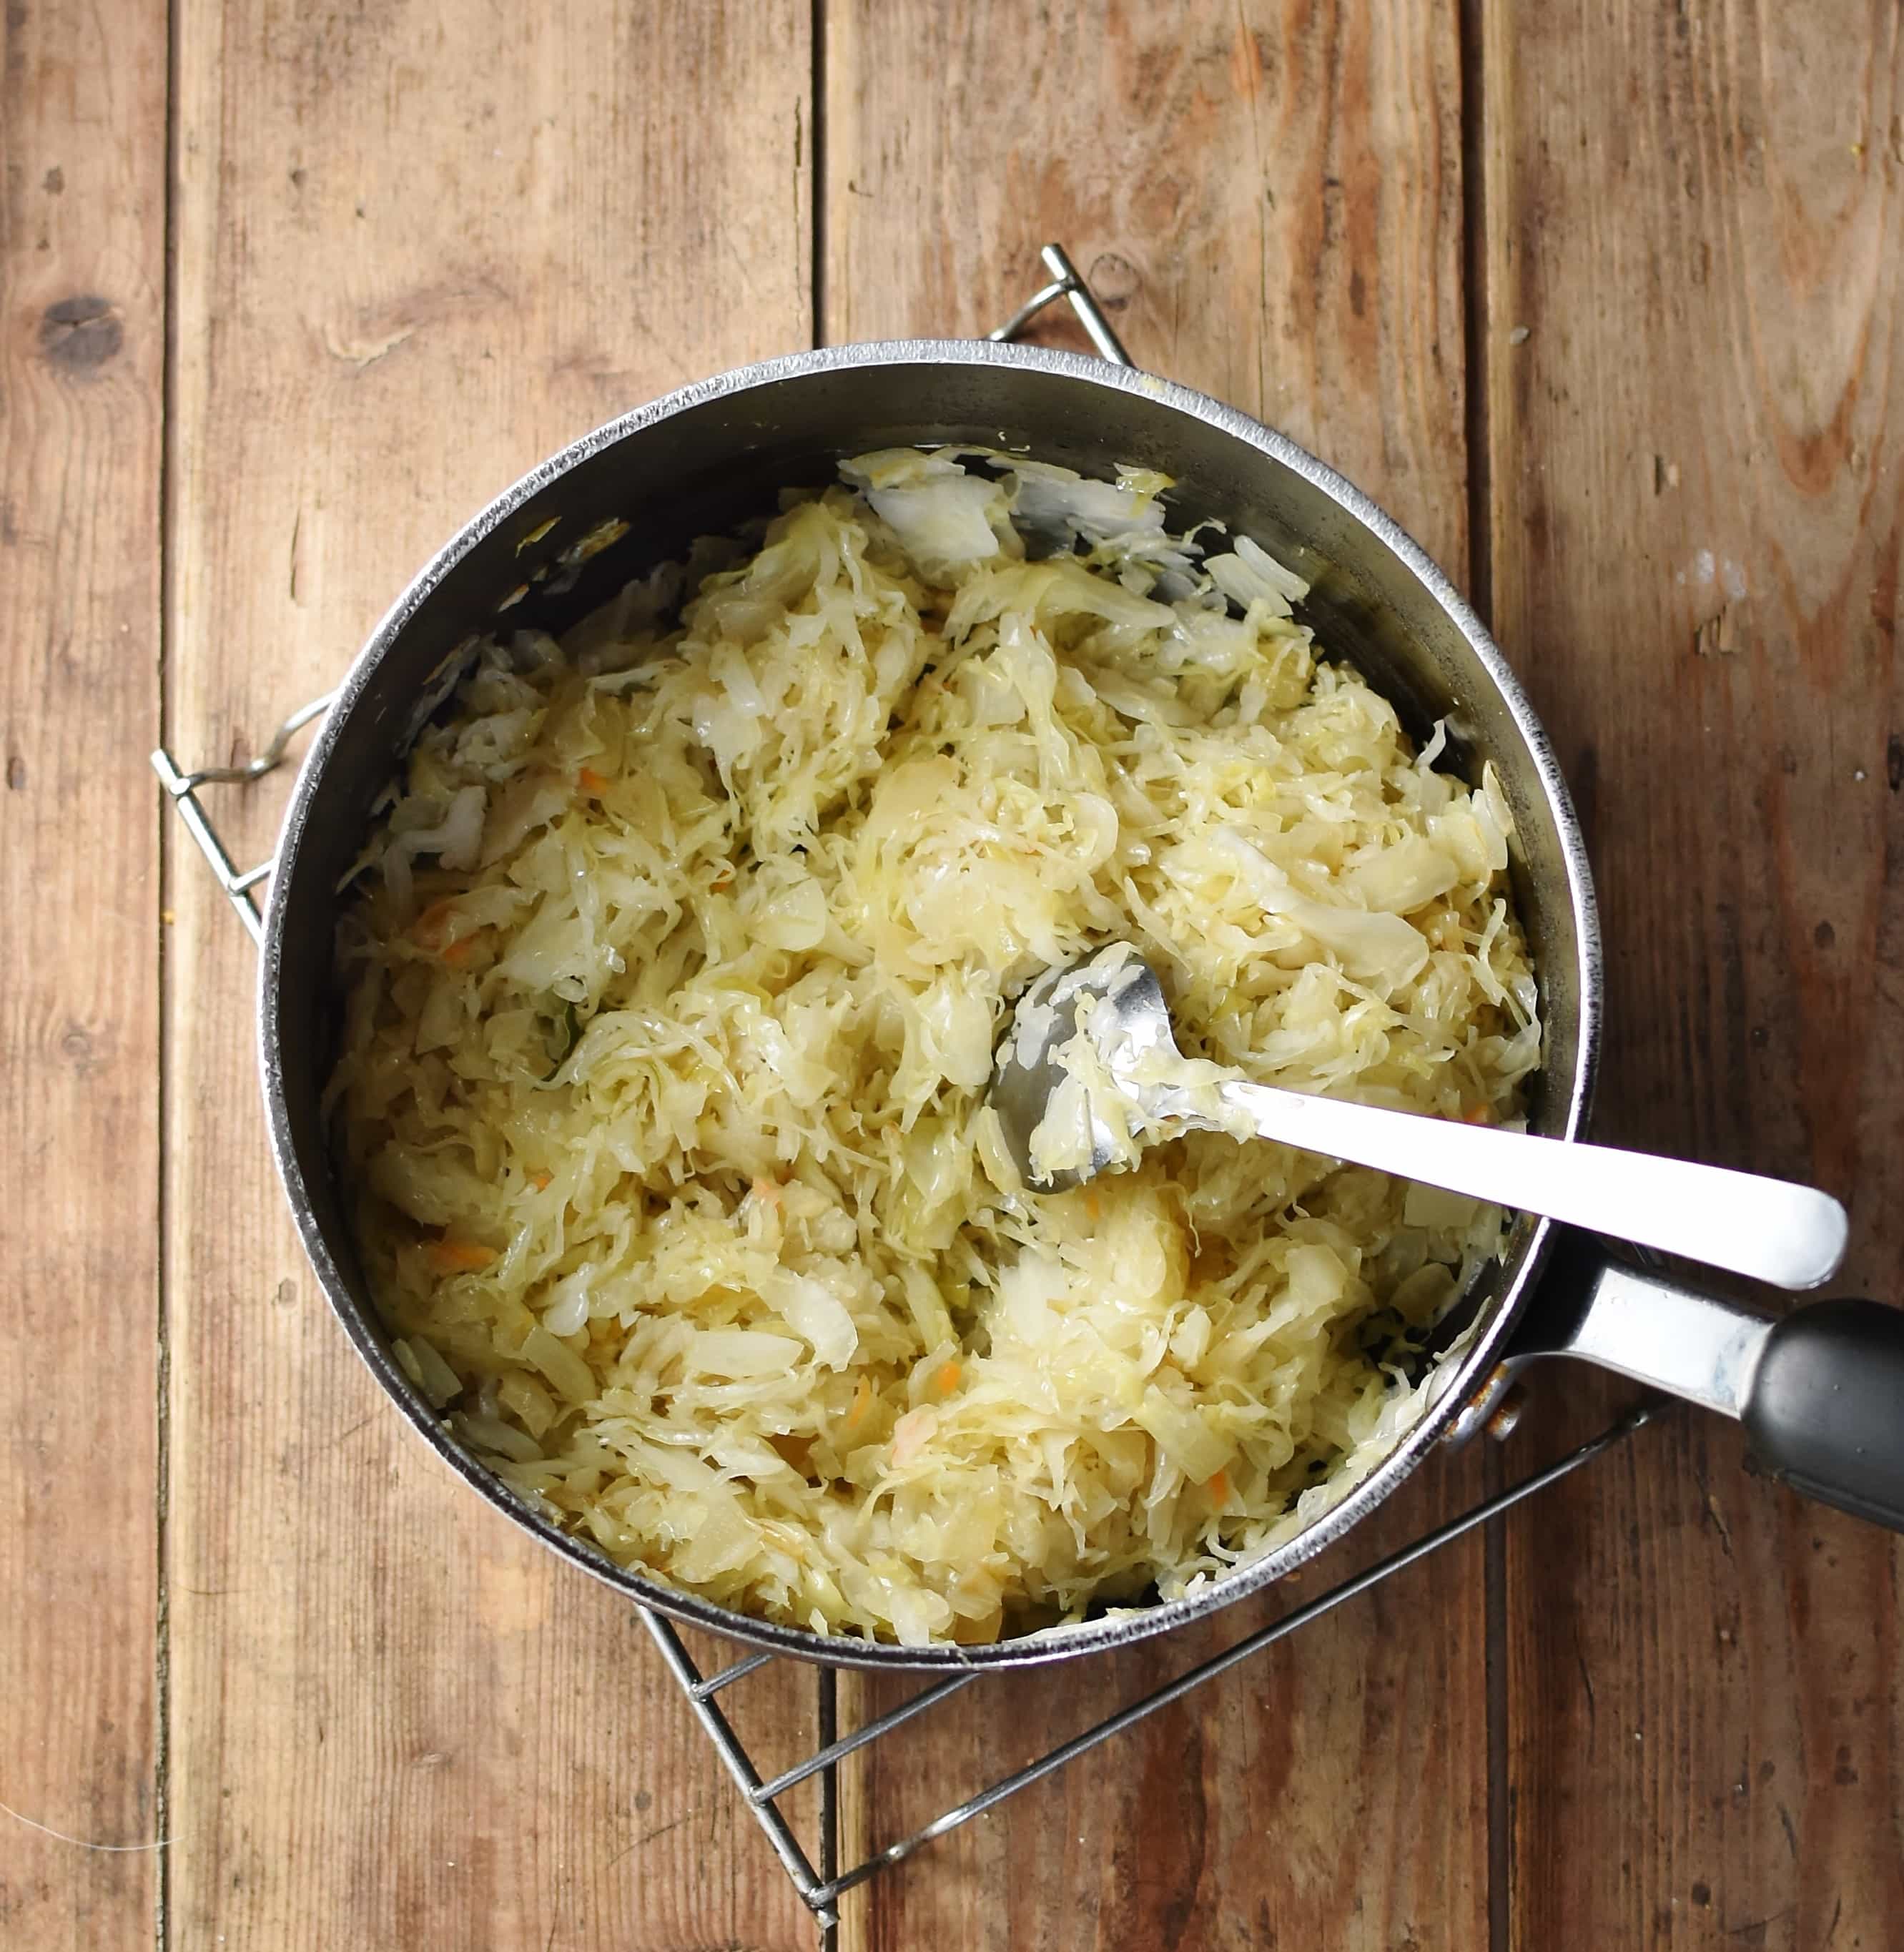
[1482,0,1904,1952]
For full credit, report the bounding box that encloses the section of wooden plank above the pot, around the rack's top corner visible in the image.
[822,0,1466,578]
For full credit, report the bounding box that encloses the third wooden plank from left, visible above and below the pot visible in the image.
[822,0,1488,1952]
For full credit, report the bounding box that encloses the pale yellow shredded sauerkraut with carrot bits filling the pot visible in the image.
[330,451,1541,1644]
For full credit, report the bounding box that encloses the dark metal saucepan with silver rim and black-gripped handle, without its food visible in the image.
[160,252,1904,1667]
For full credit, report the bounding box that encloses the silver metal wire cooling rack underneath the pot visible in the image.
[152,244,1660,1944]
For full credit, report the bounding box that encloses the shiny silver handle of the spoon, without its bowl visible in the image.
[1189,1080,1848,1288]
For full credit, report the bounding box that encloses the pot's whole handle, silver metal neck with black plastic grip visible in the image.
[1496,1233,1904,1532]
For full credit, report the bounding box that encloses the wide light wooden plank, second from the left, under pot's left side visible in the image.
[166,0,817,1952]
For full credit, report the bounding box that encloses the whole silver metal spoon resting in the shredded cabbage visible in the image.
[990,943,1848,1288]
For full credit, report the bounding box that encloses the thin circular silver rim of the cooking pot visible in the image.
[258,340,1603,1669]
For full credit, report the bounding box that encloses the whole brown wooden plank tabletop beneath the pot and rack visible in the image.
[0,0,1904,1952]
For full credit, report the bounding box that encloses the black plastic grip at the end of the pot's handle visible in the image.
[1740,1300,1904,1532]
